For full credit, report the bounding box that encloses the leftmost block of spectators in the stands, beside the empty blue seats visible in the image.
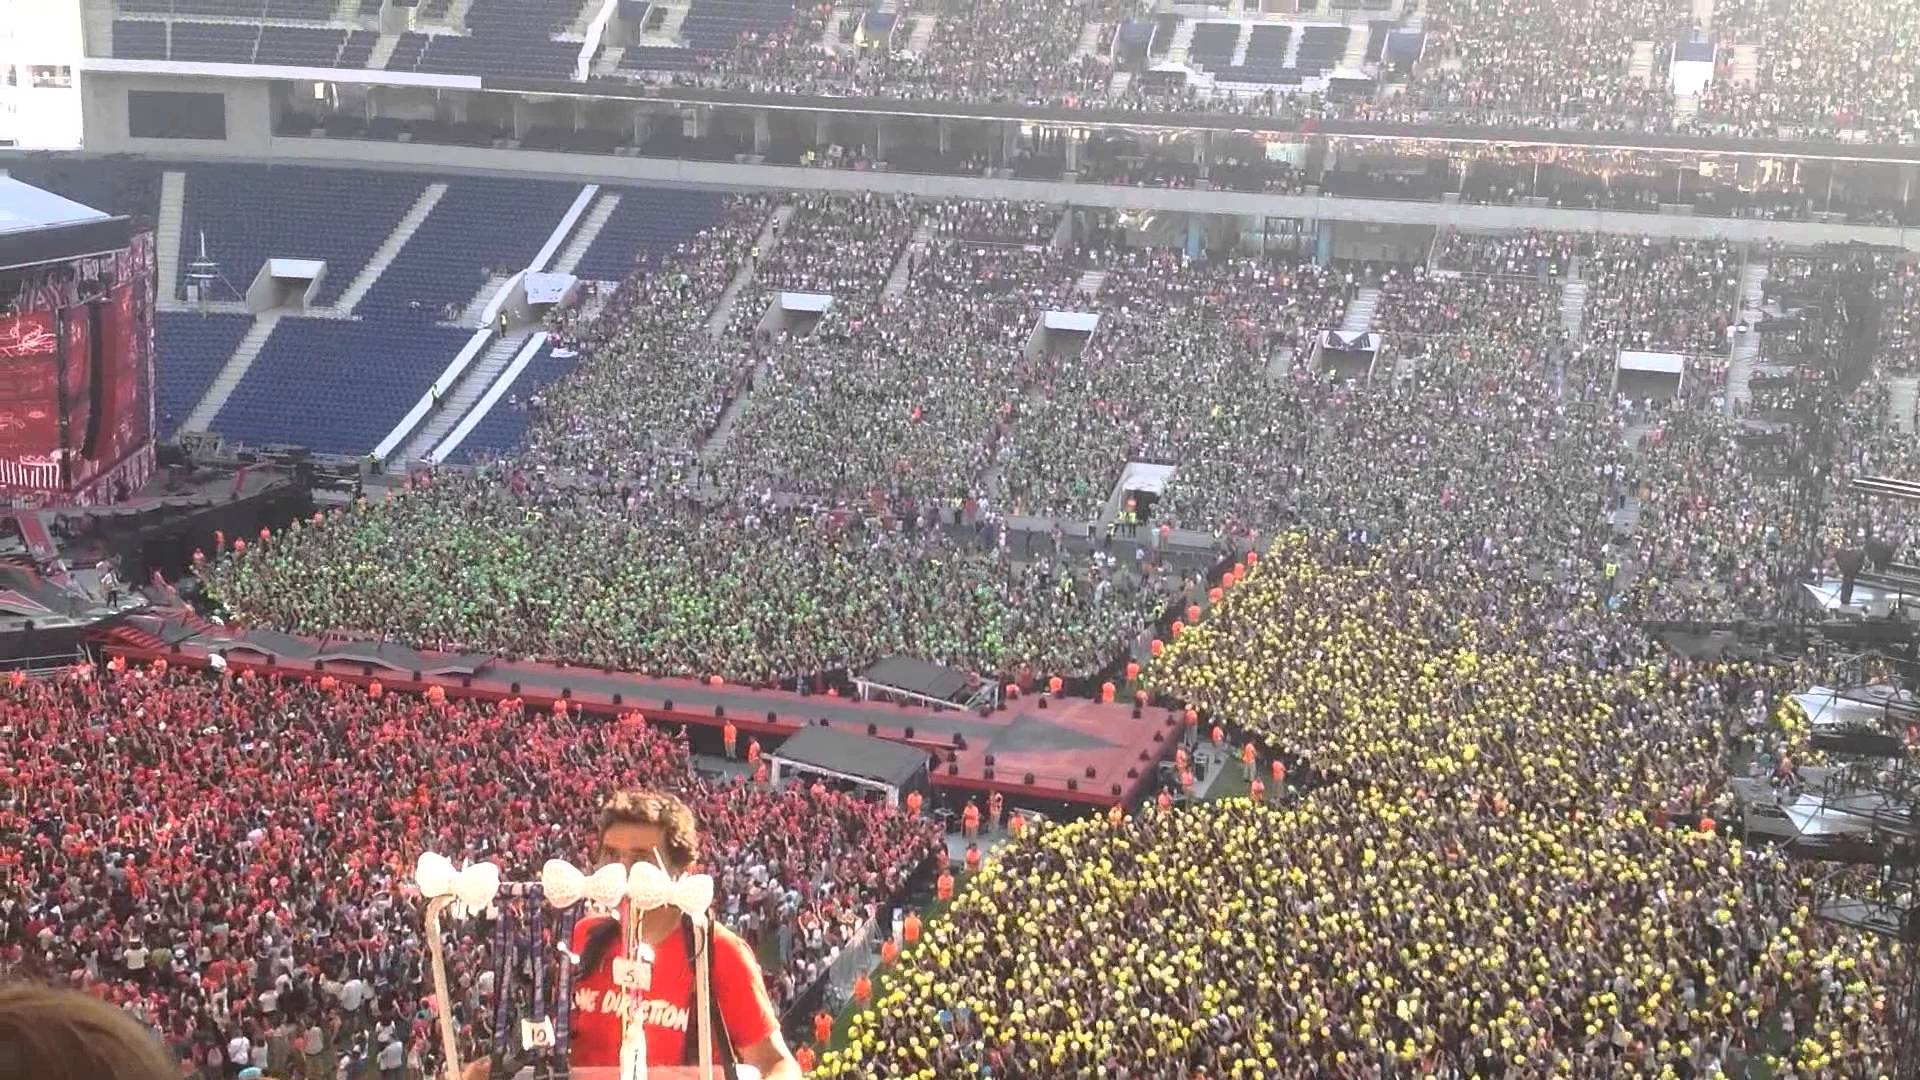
[524,198,770,484]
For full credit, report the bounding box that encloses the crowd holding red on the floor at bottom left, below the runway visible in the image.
[0,661,939,1076]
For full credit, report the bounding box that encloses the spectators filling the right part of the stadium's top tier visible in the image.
[599,0,1920,138]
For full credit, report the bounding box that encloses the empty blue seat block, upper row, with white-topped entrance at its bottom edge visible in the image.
[180,165,426,304]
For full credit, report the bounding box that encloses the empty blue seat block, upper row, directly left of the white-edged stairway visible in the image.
[355,177,580,323]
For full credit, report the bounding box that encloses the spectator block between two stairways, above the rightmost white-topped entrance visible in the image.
[1580,234,1741,354]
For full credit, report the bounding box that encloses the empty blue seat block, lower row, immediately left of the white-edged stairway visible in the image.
[213,317,472,455]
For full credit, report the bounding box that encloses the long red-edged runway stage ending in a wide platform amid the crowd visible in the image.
[104,611,1181,807]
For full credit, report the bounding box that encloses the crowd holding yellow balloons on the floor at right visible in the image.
[822,532,1895,1080]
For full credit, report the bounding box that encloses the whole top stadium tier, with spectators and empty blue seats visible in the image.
[101,0,1920,140]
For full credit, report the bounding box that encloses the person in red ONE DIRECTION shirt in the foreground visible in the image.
[465,788,801,1080]
